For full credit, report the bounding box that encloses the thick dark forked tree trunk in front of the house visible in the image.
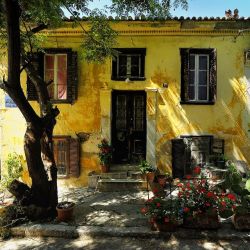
[3,0,59,214]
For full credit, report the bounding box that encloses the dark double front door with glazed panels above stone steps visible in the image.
[112,91,146,163]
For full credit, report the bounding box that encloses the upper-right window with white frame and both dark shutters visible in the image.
[180,49,216,104]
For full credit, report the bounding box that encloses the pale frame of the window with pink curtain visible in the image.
[44,53,68,100]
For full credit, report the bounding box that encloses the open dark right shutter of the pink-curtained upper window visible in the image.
[67,51,78,103]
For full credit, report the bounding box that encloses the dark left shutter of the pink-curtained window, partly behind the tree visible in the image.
[27,52,44,101]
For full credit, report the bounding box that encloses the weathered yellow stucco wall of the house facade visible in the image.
[1,21,250,186]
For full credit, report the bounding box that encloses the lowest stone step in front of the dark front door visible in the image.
[97,178,147,192]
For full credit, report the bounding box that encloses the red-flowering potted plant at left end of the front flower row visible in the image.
[141,196,181,231]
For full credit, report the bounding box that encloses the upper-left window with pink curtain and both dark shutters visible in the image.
[27,49,77,103]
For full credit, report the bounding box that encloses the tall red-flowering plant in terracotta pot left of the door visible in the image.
[98,139,112,173]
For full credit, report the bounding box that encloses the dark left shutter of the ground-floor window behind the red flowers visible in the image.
[172,139,186,178]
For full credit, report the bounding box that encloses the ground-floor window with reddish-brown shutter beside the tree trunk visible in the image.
[53,136,80,177]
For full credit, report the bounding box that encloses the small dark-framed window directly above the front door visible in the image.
[111,49,146,81]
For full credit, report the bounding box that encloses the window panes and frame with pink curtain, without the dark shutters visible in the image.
[44,54,67,100]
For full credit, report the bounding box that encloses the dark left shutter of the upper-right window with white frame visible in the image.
[180,49,189,102]
